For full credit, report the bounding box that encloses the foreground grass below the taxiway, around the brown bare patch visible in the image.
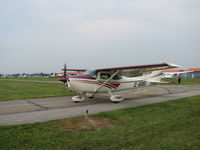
[0,96,200,150]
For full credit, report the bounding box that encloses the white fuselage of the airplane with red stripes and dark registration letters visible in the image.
[67,72,151,94]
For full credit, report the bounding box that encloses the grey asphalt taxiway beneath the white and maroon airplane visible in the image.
[0,85,200,125]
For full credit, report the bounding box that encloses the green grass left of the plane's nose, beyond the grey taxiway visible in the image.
[0,80,74,101]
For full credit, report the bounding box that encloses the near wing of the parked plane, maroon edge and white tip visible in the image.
[96,63,180,76]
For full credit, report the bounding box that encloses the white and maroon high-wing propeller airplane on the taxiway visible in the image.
[60,63,180,103]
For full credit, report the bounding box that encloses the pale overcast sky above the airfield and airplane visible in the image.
[0,0,200,74]
